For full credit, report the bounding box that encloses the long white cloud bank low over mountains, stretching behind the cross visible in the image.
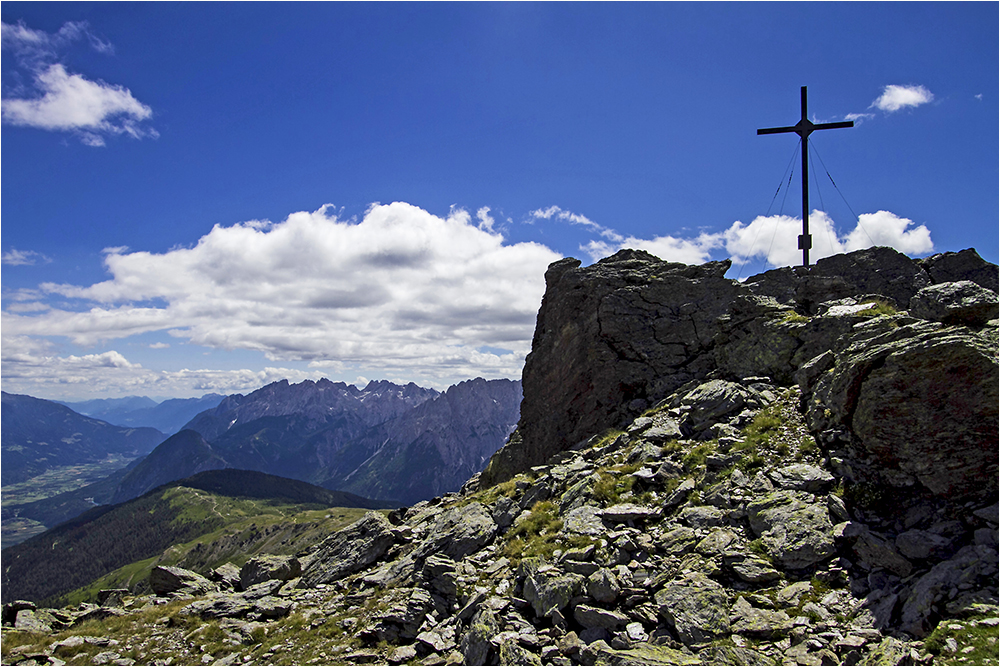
[3,202,933,396]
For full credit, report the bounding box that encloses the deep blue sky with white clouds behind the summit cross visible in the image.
[0,2,1000,399]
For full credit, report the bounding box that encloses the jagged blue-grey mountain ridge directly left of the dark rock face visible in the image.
[112,378,521,503]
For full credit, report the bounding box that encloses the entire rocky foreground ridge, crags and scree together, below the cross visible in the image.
[2,248,1000,665]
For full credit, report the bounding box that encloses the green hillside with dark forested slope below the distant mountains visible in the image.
[3,470,394,602]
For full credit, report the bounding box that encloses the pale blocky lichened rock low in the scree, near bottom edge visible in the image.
[655,573,731,646]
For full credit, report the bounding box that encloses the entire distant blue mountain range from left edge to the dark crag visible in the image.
[3,378,521,544]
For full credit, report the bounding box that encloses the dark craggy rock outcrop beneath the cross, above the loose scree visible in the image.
[482,248,1000,504]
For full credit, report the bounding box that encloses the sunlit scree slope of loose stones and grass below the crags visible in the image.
[2,378,998,665]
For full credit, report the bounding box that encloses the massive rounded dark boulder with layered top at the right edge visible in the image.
[804,318,1000,498]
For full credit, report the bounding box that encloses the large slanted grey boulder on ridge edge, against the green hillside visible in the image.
[299,512,395,588]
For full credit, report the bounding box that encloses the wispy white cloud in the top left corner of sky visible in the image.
[0,23,158,146]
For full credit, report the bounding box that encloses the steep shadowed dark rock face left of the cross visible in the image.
[484,250,739,483]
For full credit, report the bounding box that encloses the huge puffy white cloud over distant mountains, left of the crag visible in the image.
[3,203,560,392]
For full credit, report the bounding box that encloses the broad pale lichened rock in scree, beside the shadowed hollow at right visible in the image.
[747,491,834,569]
